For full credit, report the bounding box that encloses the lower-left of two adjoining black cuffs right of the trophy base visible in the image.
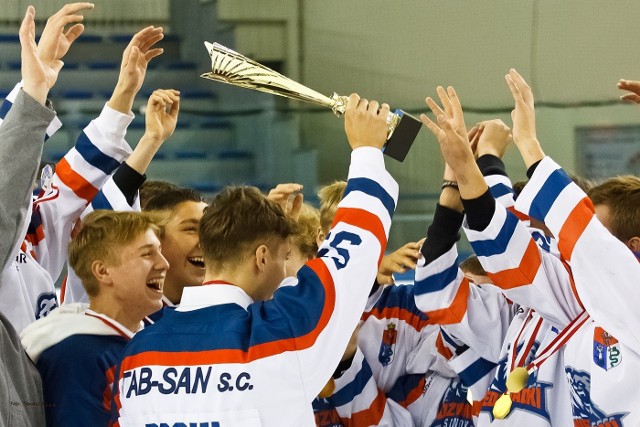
[420,203,464,264]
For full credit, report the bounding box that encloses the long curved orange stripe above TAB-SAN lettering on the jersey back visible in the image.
[122,258,336,372]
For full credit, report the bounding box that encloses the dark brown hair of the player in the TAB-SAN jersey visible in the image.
[200,186,296,270]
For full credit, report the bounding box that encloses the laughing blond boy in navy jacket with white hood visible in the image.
[22,211,169,426]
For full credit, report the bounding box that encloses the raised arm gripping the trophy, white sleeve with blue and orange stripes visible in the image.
[256,94,398,402]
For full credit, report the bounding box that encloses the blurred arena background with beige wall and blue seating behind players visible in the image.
[0,0,640,254]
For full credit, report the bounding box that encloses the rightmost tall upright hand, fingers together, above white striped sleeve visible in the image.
[505,68,544,168]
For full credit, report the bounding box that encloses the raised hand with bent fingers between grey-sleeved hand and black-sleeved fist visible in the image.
[109,26,164,114]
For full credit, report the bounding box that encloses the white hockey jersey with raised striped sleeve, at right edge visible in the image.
[516,157,640,427]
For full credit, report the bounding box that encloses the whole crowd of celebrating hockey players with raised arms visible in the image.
[0,3,640,427]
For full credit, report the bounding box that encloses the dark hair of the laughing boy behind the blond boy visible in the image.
[140,181,204,211]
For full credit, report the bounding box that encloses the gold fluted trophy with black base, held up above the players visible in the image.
[201,42,422,161]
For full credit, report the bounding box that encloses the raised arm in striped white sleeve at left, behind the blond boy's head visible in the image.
[27,27,162,280]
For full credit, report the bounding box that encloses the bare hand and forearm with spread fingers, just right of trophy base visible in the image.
[420,86,486,199]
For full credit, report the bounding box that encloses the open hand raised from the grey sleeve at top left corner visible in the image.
[19,3,93,105]
